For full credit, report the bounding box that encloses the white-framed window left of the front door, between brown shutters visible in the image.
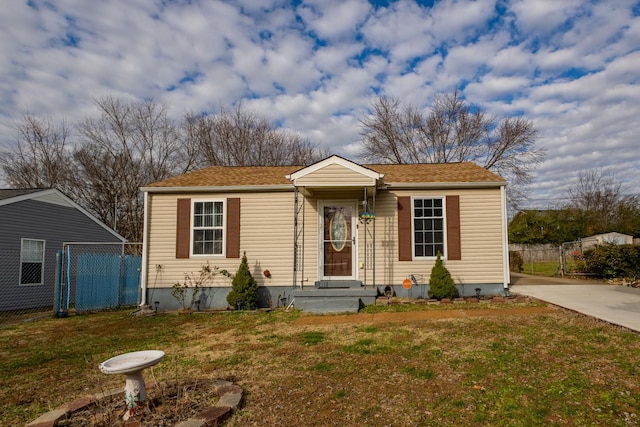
[192,201,225,255]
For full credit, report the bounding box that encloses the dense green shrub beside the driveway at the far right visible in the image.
[584,245,640,280]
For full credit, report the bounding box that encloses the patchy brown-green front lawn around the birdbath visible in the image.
[0,305,640,426]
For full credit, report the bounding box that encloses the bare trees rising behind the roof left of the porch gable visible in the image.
[183,104,325,166]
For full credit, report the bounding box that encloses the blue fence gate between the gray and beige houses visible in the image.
[56,243,142,312]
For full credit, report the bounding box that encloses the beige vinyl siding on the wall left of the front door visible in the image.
[147,192,300,288]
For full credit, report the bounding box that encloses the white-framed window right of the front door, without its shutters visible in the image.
[413,197,446,258]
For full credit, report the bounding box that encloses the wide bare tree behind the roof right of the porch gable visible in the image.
[361,91,545,211]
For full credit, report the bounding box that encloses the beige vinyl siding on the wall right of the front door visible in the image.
[368,188,503,285]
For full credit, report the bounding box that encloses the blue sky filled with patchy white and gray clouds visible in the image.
[0,0,640,205]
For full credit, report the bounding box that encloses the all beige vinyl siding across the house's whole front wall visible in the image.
[147,188,503,289]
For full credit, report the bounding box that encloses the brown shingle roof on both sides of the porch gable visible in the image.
[147,162,504,188]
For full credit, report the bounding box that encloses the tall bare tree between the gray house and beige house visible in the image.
[73,97,196,241]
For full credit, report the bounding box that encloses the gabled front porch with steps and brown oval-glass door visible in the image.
[287,156,383,313]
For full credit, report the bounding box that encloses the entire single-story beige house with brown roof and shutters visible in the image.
[141,156,510,311]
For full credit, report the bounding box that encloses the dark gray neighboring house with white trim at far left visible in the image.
[0,189,125,311]
